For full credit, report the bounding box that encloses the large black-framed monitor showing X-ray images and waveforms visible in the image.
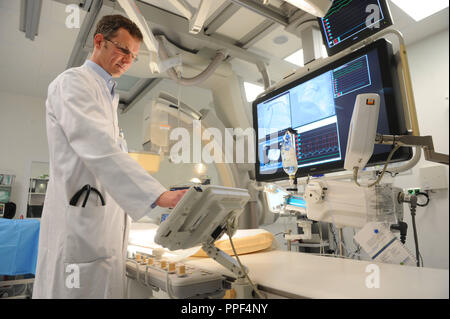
[253,39,412,181]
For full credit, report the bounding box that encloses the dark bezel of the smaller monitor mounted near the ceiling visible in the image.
[317,0,393,56]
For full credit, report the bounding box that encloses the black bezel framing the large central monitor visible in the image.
[252,39,412,182]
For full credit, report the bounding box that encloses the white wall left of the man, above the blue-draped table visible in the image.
[0,92,48,218]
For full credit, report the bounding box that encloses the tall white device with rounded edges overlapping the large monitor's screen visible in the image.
[344,94,380,171]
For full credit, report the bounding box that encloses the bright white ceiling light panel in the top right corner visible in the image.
[392,0,449,21]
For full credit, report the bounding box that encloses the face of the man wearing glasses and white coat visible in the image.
[95,28,141,78]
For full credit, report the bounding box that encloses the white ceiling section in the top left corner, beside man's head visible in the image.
[0,0,84,97]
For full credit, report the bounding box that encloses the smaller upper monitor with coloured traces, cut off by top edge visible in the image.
[319,0,392,56]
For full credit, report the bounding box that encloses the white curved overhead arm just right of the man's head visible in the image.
[118,0,161,73]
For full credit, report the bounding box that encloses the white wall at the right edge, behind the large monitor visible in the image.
[395,29,449,269]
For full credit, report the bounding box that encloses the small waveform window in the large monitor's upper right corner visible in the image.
[332,55,372,98]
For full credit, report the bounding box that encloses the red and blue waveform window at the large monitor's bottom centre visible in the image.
[297,123,340,165]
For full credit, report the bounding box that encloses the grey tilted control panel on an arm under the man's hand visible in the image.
[155,185,250,278]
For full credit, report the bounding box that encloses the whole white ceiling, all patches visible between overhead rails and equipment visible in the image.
[0,0,449,103]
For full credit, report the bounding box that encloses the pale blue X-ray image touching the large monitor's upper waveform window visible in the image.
[291,72,336,129]
